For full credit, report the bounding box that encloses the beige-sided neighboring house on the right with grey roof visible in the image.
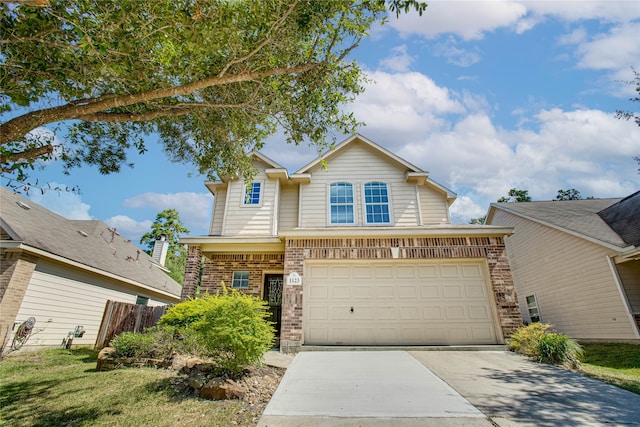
[486,192,640,342]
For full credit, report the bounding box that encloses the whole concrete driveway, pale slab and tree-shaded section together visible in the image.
[258,351,640,427]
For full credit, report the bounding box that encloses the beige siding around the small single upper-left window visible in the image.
[222,162,280,236]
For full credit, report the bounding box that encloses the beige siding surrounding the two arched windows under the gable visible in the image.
[300,143,419,228]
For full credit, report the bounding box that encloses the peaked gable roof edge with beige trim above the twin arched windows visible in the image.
[293,133,457,204]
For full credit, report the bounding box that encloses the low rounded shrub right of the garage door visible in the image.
[509,323,583,368]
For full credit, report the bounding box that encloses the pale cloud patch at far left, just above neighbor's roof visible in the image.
[28,182,92,219]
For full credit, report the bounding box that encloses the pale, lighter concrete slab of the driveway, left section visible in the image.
[258,351,491,426]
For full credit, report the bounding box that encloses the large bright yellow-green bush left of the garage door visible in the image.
[160,290,274,374]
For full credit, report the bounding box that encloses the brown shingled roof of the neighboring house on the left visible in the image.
[0,187,181,298]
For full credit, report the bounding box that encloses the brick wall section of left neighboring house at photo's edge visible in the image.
[0,249,38,350]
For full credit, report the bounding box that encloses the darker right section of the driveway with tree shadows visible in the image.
[410,351,640,427]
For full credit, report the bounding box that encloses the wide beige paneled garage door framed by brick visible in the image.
[303,260,500,345]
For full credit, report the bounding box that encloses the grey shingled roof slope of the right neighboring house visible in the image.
[487,198,628,250]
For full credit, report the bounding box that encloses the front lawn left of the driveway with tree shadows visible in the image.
[0,350,259,427]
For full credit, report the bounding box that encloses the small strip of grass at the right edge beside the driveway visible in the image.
[581,343,640,394]
